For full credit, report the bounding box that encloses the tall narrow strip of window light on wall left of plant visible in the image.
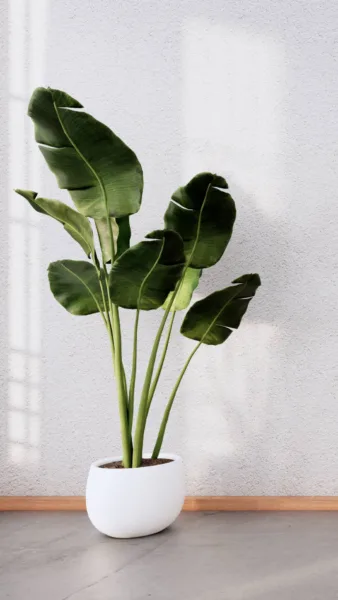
[7,0,48,466]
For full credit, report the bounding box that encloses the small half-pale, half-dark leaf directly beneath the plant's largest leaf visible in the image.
[95,217,131,262]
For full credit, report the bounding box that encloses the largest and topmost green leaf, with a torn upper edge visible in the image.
[28,88,143,219]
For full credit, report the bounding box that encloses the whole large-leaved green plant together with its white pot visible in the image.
[16,88,260,537]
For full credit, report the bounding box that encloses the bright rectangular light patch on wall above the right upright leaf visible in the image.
[182,19,284,217]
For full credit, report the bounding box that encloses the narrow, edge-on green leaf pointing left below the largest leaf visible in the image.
[15,190,94,256]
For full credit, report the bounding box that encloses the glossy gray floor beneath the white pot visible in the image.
[0,513,338,600]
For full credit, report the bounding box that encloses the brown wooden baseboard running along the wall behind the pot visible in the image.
[0,496,338,511]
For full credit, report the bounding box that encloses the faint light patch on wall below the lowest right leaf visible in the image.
[178,324,278,481]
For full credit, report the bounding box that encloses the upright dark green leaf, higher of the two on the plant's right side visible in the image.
[164,173,236,269]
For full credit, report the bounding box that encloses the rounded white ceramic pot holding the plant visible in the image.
[86,454,185,538]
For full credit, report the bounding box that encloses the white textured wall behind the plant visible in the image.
[0,0,338,495]
